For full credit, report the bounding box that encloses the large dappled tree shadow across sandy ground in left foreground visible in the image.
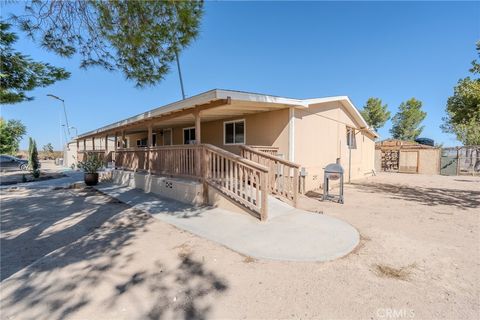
[1,190,228,319]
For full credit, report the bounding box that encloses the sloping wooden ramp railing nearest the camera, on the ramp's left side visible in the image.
[202,145,268,220]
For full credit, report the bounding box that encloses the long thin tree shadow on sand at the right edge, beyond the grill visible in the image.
[352,183,480,210]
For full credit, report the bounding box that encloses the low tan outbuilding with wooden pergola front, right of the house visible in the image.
[375,139,441,174]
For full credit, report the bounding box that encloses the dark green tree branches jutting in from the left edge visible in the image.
[0,21,70,104]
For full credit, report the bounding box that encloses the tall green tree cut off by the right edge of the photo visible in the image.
[441,41,480,145]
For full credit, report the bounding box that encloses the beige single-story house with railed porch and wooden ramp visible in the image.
[71,89,378,220]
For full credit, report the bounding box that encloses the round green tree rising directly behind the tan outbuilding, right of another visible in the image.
[390,98,427,140]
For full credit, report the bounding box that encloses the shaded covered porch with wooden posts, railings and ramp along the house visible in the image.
[77,90,300,220]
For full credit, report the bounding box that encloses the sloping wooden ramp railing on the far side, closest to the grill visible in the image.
[241,146,300,206]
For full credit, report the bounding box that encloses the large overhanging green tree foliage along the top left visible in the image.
[14,0,203,87]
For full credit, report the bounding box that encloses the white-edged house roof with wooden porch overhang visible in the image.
[77,89,376,139]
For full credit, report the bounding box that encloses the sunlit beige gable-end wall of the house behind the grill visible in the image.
[295,102,375,190]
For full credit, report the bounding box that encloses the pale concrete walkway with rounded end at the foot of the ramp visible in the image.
[96,183,359,261]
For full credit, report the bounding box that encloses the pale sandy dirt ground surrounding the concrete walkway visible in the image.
[0,174,480,319]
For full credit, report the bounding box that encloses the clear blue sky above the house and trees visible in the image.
[1,2,480,148]
